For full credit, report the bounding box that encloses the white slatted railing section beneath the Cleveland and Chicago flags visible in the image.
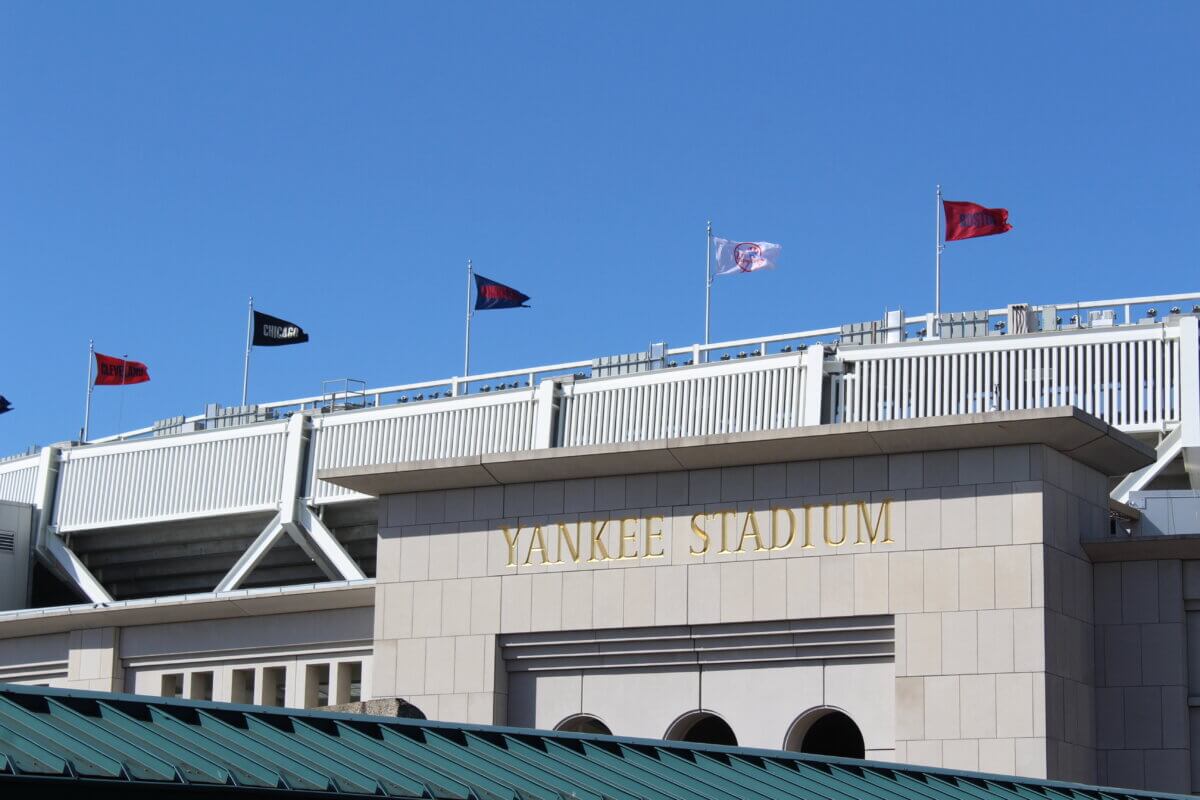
[54,421,287,533]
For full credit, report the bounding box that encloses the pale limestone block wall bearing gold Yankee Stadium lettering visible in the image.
[374,446,1106,780]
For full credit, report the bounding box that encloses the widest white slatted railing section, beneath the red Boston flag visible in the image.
[832,325,1180,432]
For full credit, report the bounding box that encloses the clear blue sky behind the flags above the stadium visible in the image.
[0,1,1200,453]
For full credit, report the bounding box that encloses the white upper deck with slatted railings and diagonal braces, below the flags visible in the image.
[0,294,1200,602]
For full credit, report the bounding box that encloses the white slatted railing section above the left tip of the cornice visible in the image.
[306,389,536,504]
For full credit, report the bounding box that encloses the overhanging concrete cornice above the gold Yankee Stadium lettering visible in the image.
[317,407,1154,497]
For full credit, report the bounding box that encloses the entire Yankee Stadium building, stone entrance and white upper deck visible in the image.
[0,295,1200,792]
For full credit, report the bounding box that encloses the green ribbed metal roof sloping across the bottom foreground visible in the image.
[0,685,1181,800]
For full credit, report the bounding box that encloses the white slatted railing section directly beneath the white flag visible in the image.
[558,355,805,447]
